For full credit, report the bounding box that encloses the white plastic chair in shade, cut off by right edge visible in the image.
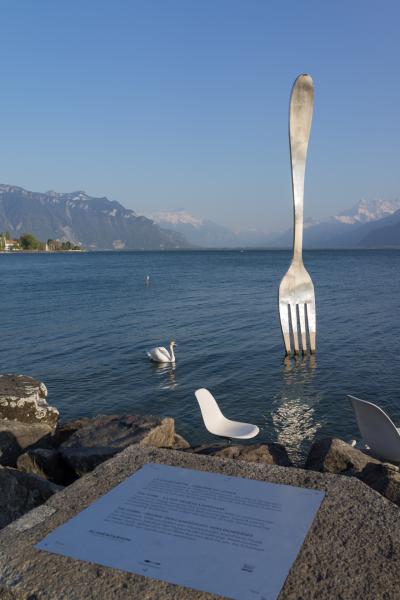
[348,396,400,462]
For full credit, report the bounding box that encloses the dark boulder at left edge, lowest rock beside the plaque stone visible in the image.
[0,467,62,528]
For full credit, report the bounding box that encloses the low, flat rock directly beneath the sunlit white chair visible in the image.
[193,443,292,467]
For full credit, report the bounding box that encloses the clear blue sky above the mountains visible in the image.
[0,0,400,231]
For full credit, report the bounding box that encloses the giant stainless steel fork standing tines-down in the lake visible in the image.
[279,75,316,354]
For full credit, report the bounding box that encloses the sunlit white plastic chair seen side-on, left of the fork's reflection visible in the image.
[194,388,260,440]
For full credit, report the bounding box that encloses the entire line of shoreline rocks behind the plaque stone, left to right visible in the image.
[0,375,400,528]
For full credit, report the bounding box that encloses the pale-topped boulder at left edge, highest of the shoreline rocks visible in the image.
[0,375,59,430]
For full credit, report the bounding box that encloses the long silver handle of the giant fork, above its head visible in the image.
[289,75,314,262]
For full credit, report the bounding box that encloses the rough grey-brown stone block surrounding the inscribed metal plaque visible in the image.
[0,446,400,600]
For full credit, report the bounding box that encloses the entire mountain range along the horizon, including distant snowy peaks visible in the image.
[0,184,400,250]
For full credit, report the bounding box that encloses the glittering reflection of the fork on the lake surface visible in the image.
[271,356,322,462]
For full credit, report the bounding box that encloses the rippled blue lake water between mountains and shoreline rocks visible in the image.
[0,250,400,457]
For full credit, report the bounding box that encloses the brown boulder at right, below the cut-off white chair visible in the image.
[305,438,400,506]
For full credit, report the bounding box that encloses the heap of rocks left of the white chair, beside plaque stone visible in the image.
[0,375,195,528]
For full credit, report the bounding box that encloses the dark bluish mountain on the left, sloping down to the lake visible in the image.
[0,184,190,250]
